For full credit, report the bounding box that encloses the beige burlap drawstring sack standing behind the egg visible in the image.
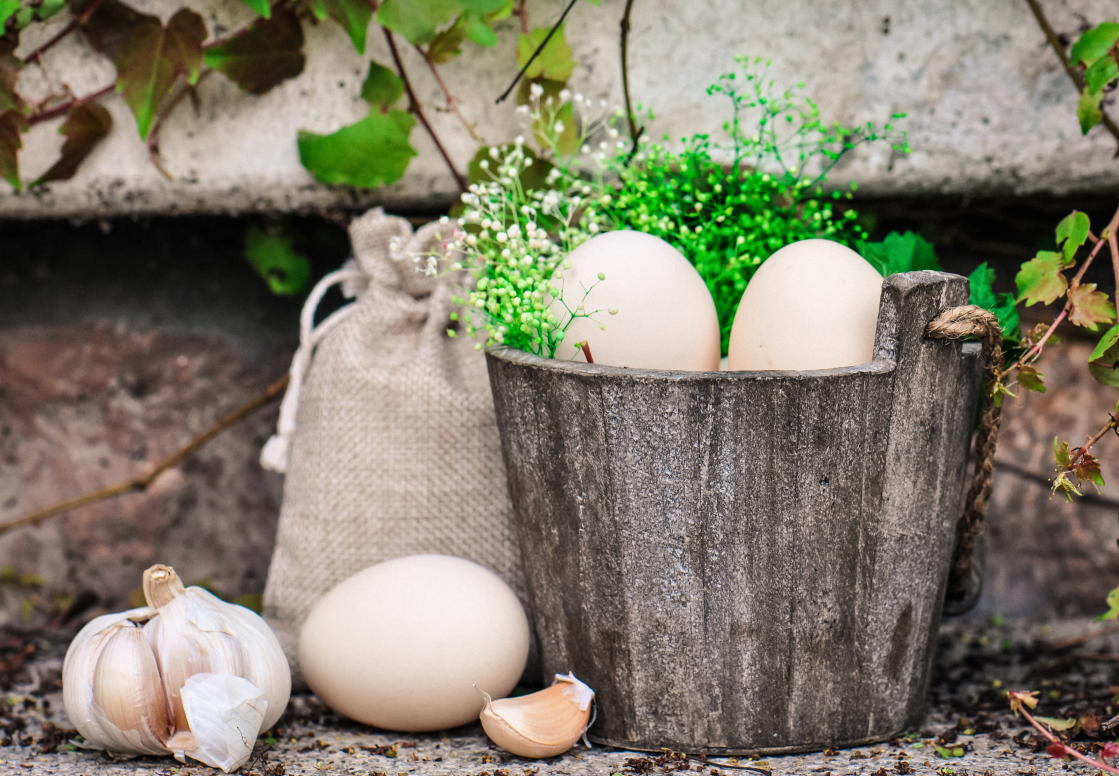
[262,208,530,685]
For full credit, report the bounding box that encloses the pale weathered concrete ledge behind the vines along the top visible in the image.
[0,0,1119,217]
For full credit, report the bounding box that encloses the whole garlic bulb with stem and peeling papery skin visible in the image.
[63,565,291,773]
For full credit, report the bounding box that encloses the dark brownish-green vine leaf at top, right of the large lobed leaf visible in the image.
[206,6,305,94]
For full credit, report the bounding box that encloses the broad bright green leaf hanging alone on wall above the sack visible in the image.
[299,111,416,188]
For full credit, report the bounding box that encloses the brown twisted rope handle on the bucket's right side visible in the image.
[925,305,1004,614]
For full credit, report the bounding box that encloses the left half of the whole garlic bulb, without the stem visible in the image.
[63,607,170,755]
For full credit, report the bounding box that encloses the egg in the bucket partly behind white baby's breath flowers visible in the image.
[549,230,720,372]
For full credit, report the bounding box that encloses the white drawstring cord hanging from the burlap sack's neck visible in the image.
[261,265,365,474]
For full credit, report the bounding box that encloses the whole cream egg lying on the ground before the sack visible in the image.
[299,554,528,732]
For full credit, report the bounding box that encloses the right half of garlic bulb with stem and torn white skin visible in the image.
[144,565,291,773]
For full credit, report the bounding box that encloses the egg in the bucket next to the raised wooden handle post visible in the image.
[727,240,882,372]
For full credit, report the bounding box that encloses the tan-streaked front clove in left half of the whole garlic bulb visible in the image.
[83,620,170,755]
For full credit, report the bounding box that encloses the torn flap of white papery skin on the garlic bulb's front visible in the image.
[182,674,269,774]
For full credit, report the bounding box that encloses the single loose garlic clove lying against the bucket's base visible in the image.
[480,674,594,758]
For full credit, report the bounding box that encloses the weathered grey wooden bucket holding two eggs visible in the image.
[487,271,981,754]
